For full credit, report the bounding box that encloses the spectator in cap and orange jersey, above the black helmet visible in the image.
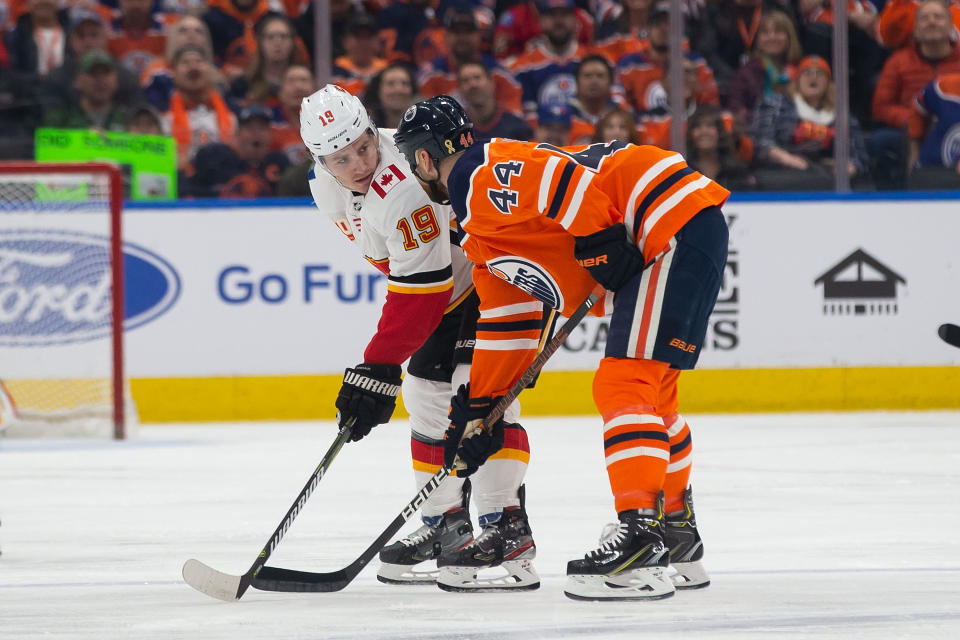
[418,7,522,114]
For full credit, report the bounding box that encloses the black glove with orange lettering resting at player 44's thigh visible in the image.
[573,223,643,291]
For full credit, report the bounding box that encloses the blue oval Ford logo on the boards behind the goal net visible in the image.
[0,230,180,347]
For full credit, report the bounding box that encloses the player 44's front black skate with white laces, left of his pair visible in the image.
[563,509,676,600]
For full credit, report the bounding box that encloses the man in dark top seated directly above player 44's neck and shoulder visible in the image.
[457,62,533,140]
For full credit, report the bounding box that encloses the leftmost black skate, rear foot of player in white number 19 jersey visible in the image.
[377,494,473,584]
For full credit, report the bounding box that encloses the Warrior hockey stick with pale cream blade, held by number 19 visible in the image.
[182,415,354,602]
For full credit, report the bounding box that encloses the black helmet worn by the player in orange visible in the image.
[393,95,473,175]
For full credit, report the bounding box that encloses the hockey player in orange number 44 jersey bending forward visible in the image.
[395,96,729,600]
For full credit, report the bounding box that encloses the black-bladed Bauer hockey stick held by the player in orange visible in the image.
[252,285,604,592]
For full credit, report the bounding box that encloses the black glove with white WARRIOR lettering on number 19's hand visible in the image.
[335,363,401,442]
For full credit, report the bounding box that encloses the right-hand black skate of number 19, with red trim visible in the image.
[437,500,540,592]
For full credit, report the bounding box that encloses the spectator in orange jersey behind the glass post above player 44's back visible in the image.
[617,2,720,114]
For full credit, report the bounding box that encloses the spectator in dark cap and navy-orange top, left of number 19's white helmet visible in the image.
[186,104,290,198]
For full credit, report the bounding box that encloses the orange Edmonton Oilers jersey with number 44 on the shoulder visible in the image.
[447,139,730,396]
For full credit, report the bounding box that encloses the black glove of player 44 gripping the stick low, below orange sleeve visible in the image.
[443,384,504,478]
